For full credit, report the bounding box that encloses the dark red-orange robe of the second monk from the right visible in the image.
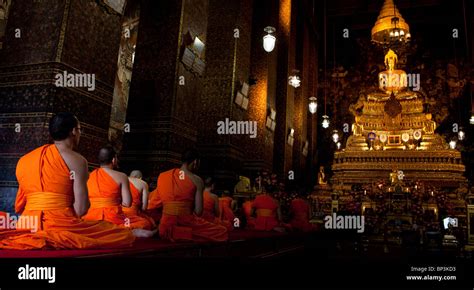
[252,194,280,231]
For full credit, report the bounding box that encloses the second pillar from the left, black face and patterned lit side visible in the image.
[121,0,209,186]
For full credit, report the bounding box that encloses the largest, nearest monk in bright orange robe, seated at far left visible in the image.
[0,113,135,250]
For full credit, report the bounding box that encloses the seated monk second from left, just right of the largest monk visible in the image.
[83,146,155,237]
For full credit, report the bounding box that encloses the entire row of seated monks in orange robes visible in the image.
[0,113,313,250]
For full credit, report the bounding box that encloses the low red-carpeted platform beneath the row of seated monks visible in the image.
[0,230,309,258]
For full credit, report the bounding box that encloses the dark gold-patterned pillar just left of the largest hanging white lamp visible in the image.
[198,0,256,189]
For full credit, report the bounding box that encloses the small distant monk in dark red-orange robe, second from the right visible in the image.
[252,190,285,232]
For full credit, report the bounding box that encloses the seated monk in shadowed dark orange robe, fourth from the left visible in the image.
[158,150,228,241]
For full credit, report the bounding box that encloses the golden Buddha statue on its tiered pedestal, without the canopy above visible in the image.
[330,32,465,185]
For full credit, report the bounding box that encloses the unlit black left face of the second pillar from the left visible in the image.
[121,1,185,184]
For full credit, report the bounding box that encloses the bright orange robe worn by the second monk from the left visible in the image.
[83,168,152,230]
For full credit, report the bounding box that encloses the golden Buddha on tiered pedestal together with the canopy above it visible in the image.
[324,0,467,227]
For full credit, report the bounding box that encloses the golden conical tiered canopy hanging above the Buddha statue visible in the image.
[372,0,411,44]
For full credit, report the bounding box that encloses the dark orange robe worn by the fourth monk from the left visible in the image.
[158,168,228,241]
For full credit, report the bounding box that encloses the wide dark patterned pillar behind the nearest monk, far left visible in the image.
[0,0,124,211]
